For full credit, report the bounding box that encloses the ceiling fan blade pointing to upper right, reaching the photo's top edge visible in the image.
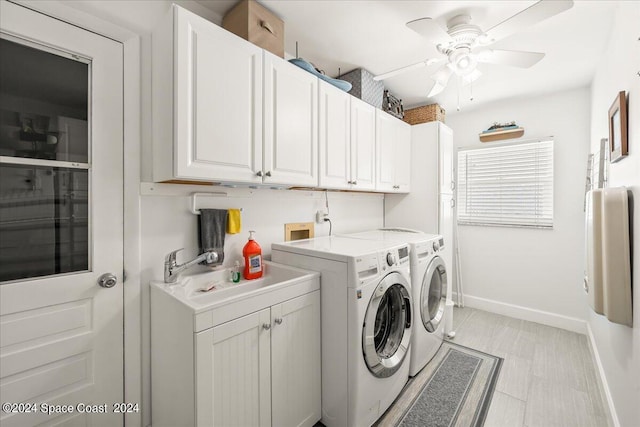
[487,0,573,43]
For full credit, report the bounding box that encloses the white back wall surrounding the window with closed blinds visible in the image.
[447,88,590,332]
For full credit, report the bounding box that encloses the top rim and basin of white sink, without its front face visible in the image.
[151,261,319,313]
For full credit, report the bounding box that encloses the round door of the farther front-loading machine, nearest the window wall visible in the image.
[420,256,447,332]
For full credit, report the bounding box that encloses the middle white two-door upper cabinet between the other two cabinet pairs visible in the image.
[319,81,375,190]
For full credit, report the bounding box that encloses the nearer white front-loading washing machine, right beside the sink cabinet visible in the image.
[271,236,412,427]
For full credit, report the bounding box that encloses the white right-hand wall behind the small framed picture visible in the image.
[588,2,640,427]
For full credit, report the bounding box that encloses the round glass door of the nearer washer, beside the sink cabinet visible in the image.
[362,272,411,378]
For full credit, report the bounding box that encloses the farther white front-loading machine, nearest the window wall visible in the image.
[344,228,451,377]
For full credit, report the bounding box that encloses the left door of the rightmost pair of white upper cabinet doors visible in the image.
[376,109,396,192]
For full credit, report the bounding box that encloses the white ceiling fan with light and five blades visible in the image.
[373,0,573,97]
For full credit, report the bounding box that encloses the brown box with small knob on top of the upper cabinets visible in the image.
[222,0,284,58]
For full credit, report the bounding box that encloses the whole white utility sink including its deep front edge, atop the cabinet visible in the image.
[151,261,320,332]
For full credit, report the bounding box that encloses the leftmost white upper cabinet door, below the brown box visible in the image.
[172,7,263,182]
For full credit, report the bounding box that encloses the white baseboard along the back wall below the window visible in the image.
[453,295,587,334]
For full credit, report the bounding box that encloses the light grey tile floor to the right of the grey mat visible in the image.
[442,307,613,427]
